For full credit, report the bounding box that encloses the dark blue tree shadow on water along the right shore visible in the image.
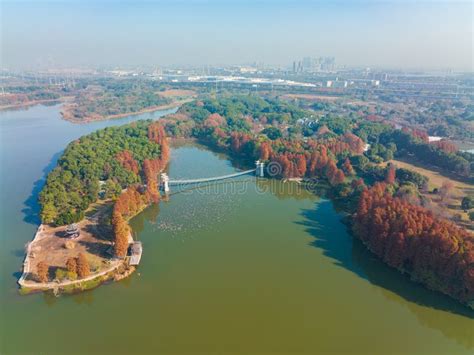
[296,201,474,319]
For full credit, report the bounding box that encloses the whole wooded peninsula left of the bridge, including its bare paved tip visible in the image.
[29,121,169,289]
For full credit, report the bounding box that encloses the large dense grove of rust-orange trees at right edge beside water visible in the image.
[353,183,474,302]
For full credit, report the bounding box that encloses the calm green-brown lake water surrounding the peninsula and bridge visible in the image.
[0,106,474,354]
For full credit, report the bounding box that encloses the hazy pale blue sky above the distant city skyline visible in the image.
[0,0,474,71]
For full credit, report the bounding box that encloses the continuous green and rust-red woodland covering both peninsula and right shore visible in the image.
[31,95,474,304]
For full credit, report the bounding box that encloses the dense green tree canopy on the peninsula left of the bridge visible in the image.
[40,121,168,225]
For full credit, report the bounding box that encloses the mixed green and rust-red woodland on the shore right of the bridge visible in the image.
[158,96,474,304]
